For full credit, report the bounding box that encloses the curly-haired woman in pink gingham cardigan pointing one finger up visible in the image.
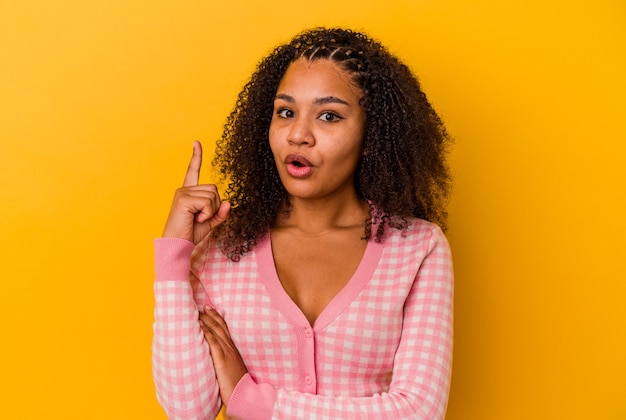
[153,28,453,419]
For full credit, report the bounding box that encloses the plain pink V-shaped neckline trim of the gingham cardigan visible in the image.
[255,233,383,331]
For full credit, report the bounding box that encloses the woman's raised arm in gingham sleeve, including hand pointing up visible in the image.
[152,142,230,419]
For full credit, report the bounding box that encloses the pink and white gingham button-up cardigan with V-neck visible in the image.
[153,219,453,420]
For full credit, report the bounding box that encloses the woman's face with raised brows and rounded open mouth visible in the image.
[269,59,365,203]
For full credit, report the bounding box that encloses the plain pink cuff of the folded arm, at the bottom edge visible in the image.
[226,373,277,420]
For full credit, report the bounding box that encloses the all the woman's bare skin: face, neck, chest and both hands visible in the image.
[163,60,369,412]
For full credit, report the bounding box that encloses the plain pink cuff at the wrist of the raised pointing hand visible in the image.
[154,238,194,281]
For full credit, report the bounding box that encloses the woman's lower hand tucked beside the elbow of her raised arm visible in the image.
[200,306,248,406]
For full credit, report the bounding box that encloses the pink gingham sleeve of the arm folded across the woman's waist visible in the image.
[228,225,453,420]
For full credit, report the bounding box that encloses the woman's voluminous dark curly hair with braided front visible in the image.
[213,28,451,261]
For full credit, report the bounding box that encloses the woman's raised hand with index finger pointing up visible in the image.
[163,141,230,244]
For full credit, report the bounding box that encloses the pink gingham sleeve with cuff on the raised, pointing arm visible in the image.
[152,238,221,420]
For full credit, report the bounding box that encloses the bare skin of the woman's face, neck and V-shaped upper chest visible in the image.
[269,59,368,325]
